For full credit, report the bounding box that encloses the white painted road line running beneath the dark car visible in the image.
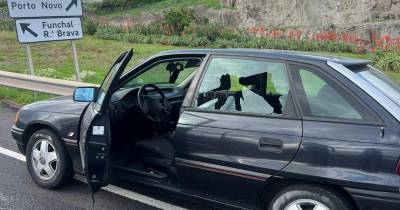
[0,147,186,210]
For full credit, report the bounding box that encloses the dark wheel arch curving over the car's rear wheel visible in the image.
[257,177,359,210]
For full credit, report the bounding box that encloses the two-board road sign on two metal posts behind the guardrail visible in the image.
[7,0,83,81]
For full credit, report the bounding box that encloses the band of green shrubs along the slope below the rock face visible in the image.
[82,6,360,53]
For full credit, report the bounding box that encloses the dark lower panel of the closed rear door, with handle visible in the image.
[174,110,302,207]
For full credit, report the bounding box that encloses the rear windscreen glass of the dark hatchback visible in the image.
[352,66,400,106]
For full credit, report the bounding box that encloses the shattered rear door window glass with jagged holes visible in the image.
[195,58,289,115]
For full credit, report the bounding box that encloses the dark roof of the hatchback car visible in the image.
[156,48,371,66]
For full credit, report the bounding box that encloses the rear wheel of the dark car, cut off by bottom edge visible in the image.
[267,185,353,210]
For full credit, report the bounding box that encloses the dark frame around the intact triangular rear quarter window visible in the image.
[287,61,384,126]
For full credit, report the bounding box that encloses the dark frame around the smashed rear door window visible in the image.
[185,54,300,119]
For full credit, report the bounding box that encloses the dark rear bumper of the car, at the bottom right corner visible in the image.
[346,188,400,210]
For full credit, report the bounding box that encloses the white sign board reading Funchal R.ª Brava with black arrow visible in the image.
[16,18,83,43]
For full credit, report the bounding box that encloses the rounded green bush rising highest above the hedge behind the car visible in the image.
[164,7,196,35]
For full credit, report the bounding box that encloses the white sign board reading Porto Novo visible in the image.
[7,0,82,18]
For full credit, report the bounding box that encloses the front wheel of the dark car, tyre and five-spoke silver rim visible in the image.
[26,129,73,189]
